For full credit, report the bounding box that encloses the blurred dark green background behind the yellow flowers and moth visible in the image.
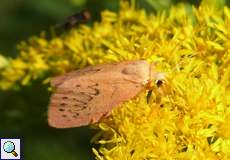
[0,0,226,160]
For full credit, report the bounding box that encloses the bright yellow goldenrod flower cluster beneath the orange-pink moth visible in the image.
[0,2,230,160]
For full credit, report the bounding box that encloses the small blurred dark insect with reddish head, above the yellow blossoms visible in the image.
[55,10,91,30]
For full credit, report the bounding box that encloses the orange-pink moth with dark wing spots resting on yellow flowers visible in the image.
[48,60,164,128]
